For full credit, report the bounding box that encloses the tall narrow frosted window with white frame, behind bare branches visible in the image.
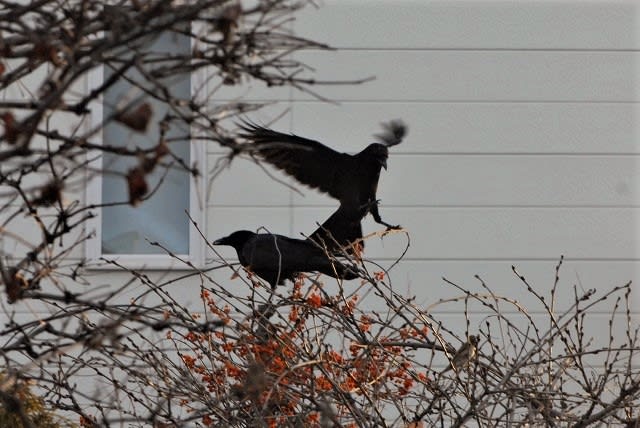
[86,25,205,268]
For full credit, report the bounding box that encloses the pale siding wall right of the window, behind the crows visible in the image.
[208,0,640,337]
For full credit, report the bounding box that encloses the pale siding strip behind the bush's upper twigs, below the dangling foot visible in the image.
[214,257,640,314]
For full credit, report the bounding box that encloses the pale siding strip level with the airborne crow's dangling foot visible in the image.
[293,205,640,260]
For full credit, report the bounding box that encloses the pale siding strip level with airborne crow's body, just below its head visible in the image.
[218,154,640,207]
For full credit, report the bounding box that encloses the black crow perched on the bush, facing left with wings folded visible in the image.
[213,230,358,287]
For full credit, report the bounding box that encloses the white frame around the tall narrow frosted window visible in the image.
[85,25,207,270]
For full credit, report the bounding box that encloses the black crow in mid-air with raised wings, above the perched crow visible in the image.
[241,120,407,232]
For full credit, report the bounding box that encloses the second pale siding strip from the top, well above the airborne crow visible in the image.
[288,50,640,102]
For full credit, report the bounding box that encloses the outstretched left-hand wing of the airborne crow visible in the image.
[241,123,352,200]
